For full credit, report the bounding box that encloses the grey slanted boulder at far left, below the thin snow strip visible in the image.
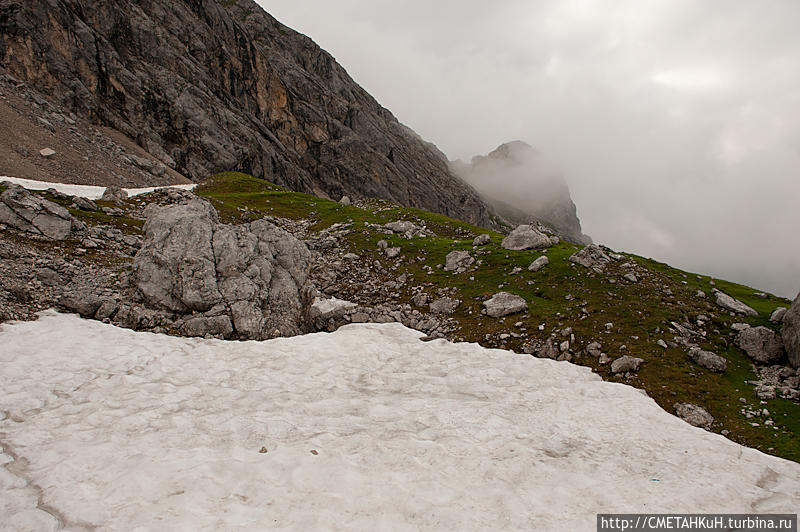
[0,185,74,240]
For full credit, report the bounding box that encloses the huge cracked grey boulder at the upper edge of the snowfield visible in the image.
[133,199,311,339]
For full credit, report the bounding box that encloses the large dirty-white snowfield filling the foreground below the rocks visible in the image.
[0,312,800,532]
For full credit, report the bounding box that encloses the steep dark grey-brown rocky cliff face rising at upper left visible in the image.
[0,0,490,225]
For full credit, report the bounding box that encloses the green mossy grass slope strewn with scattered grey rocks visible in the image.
[196,173,800,461]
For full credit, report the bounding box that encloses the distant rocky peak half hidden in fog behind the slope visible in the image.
[451,141,591,244]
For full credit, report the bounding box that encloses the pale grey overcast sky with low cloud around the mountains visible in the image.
[259,0,800,297]
